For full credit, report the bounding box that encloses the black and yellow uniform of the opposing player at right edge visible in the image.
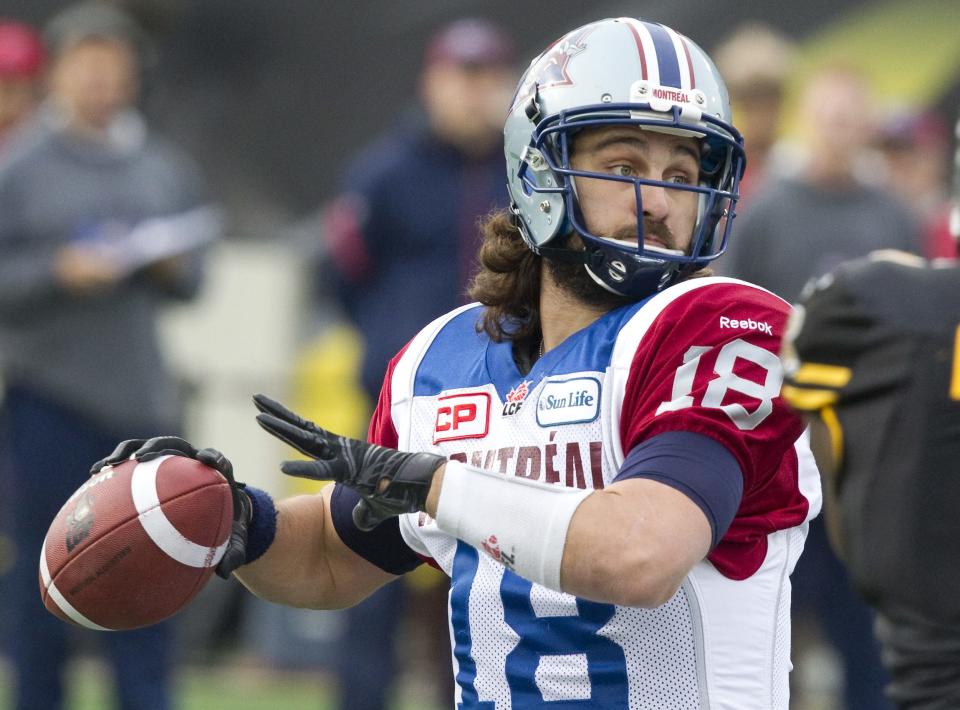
[783,252,960,708]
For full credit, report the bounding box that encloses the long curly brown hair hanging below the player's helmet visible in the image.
[468,209,542,343]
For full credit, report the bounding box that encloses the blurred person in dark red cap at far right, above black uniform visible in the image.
[873,106,956,258]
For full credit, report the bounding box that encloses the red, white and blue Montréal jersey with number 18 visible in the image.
[370,278,820,710]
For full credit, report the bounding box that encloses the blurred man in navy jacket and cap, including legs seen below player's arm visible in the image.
[324,18,517,710]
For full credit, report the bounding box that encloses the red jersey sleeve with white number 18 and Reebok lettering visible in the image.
[620,283,809,579]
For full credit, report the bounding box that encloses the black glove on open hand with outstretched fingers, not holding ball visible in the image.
[253,394,446,530]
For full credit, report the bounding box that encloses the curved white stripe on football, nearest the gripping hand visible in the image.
[130,456,229,567]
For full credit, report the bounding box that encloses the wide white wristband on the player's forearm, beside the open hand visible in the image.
[437,461,593,591]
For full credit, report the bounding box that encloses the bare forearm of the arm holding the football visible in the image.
[235,486,394,609]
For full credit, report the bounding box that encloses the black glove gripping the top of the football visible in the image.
[90,436,253,579]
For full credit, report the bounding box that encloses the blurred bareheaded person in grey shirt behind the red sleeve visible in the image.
[721,64,922,301]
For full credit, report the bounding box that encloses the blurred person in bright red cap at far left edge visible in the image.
[0,18,45,145]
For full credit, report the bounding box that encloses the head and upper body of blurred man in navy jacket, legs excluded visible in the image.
[324,19,516,400]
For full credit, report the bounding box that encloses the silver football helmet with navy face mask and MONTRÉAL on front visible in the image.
[504,18,745,298]
